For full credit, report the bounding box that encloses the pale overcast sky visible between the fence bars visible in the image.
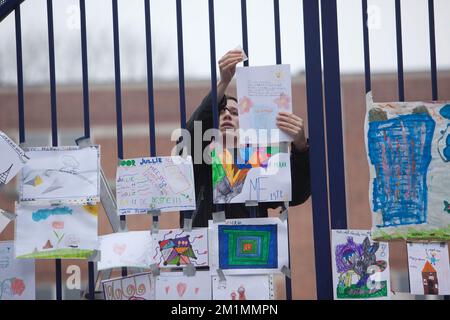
[0,0,450,86]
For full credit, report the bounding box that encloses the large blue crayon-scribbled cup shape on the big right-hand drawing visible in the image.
[368,113,435,227]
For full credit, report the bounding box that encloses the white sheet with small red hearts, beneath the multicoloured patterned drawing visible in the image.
[155,271,212,300]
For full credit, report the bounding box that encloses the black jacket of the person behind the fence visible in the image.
[180,94,311,227]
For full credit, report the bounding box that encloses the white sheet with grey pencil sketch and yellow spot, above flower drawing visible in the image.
[20,146,100,202]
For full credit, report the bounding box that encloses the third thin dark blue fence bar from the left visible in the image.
[80,0,95,300]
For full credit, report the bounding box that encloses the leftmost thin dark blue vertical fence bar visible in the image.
[14,5,25,143]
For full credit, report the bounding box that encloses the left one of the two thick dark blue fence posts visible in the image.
[303,0,333,300]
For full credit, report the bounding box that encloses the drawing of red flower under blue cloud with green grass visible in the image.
[16,202,98,259]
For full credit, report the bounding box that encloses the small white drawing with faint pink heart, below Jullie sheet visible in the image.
[98,231,152,270]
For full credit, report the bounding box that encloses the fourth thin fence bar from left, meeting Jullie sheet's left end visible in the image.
[112,0,127,277]
